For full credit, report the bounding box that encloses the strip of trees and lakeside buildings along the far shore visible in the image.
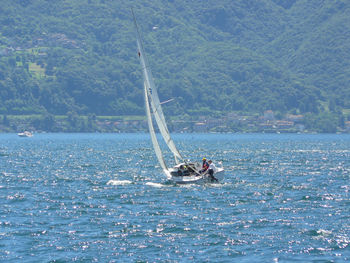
[0,110,350,133]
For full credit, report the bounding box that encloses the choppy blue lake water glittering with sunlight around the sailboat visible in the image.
[0,134,350,262]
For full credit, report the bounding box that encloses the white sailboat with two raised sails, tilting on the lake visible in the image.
[131,9,224,184]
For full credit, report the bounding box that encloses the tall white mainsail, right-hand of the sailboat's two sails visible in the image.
[133,10,183,163]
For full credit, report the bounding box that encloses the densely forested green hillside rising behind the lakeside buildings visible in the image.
[0,0,350,132]
